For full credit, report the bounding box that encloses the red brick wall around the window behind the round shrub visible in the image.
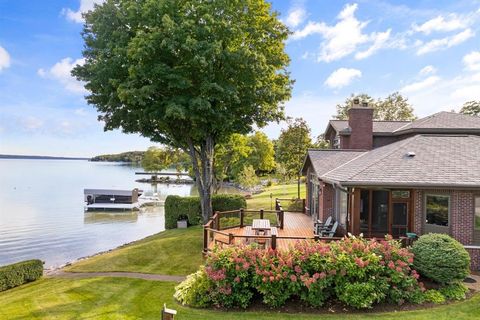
[413,190,480,270]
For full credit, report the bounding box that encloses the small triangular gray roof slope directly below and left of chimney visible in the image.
[302,149,365,176]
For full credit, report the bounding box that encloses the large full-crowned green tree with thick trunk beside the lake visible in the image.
[73,0,292,221]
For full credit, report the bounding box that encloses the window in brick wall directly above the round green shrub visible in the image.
[425,195,450,233]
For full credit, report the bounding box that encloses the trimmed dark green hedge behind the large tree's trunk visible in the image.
[165,194,247,229]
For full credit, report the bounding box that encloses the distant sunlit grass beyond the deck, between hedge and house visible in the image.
[247,183,306,210]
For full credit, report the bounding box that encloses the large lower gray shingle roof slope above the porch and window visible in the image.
[316,135,480,187]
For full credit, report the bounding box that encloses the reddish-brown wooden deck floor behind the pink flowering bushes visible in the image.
[208,212,314,250]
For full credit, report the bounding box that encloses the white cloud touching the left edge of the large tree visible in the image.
[37,58,86,93]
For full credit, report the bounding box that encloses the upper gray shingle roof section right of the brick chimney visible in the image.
[395,111,480,133]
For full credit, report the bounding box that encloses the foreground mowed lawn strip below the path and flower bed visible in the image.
[0,277,480,320]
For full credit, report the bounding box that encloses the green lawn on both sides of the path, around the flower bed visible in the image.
[0,211,480,320]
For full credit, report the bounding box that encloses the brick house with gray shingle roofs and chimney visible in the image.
[302,101,480,269]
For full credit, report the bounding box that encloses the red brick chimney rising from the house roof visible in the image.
[348,99,373,150]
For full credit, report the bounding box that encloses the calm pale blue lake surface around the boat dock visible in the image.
[0,159,199,268]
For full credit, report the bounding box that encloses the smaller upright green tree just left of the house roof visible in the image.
[276,118,312,178]
